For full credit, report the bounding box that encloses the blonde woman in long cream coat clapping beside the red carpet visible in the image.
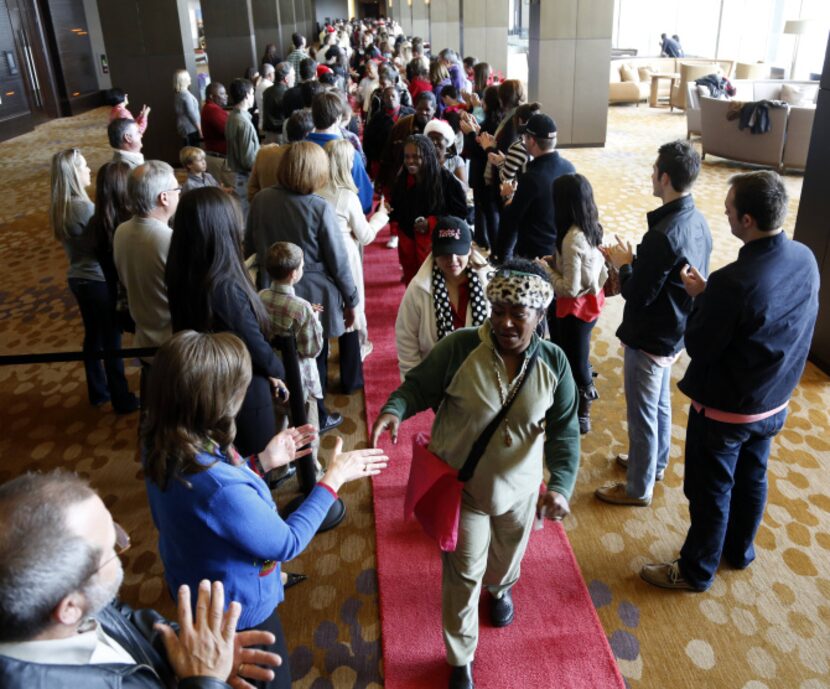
[320,139,389,359]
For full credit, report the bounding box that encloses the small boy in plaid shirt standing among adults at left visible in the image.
[259,242,323,480]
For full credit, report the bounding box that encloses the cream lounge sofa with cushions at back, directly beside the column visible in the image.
[608,57,734,107]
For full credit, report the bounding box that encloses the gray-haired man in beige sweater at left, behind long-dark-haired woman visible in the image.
[112,160,182,396]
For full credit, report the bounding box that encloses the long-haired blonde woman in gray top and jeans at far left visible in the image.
[49,148,138,414]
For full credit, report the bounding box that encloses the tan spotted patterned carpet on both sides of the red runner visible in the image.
[0,107,830,689]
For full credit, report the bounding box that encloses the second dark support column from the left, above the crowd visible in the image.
[201,0,259,86]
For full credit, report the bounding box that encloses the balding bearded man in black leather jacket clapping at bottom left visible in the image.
[0,471,280,689]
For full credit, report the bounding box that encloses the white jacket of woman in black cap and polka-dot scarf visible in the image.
[395,254,490,380]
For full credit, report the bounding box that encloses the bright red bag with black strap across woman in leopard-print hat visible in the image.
[404,348,539,552]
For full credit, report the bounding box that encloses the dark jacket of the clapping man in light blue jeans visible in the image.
[617,195,712,356]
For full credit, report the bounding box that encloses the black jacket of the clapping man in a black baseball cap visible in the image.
[496,151,576,260]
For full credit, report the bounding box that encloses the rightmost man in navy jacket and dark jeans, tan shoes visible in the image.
[640,171,819,591]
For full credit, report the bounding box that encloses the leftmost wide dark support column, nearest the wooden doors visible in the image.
[98,0,197,165]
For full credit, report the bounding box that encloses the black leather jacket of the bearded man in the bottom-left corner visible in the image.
[0,601,228,689]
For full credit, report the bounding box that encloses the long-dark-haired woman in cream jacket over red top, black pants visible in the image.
[549,174,608,433]
